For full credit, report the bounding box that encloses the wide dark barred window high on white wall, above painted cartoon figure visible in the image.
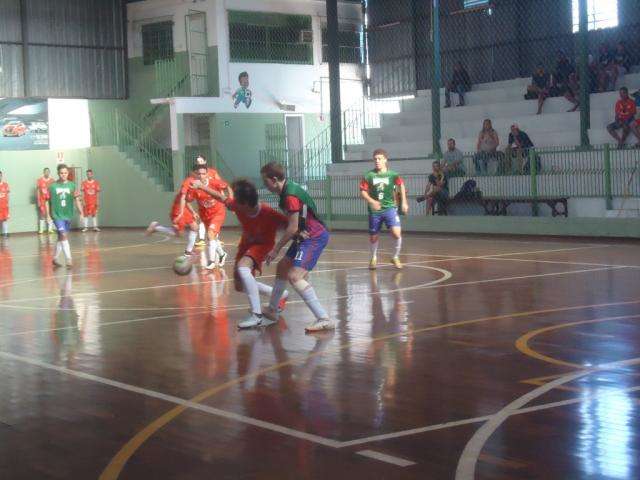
[229,11,313,65]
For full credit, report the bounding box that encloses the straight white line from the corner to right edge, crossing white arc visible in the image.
[341,386,640,448]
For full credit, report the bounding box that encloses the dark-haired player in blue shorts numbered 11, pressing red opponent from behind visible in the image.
[260,162,335,332]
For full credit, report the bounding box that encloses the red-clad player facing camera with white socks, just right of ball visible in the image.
[181,165,231,270]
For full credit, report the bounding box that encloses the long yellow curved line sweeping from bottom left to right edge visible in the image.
[99,300,640,480]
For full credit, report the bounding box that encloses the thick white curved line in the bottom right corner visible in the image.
[455,358,640,480]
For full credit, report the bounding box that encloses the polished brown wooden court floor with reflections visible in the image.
[0,230,640,480]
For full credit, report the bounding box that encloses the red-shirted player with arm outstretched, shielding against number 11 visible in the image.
[199,179,289,328]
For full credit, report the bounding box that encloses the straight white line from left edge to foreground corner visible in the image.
[0,352,340,448]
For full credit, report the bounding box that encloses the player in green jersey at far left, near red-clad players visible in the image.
[47,163,82,268]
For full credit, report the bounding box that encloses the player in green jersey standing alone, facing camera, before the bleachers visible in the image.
[360,148,409,270]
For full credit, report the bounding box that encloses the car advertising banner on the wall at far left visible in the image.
[0,98,49,150]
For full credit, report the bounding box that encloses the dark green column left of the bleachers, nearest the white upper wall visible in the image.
[326,0,342,163]
